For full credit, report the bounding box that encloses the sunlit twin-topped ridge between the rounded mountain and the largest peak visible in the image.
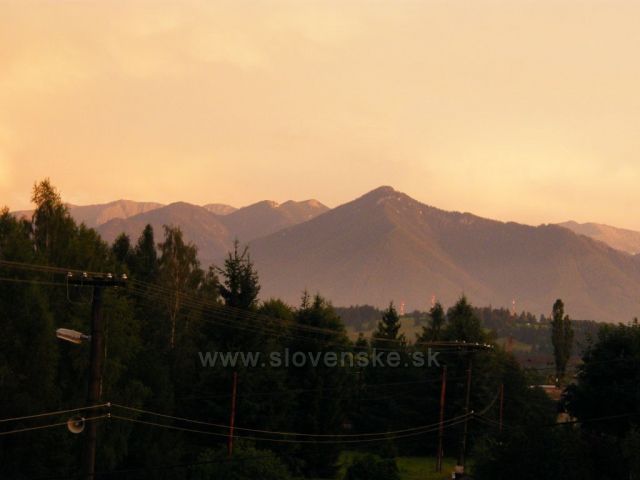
[220,200,329,242]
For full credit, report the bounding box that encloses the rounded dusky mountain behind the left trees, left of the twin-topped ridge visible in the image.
[98,202,233,266]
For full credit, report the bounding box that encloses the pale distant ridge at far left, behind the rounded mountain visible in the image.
[14,200,163,228]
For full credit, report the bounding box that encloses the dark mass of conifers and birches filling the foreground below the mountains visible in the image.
[0,180,640,479]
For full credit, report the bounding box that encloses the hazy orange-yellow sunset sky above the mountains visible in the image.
[0,0,640,230]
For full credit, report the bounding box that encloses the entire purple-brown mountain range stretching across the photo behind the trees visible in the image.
[10,187,640,322]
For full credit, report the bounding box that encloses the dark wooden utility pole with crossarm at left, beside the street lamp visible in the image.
[68,274,126,480]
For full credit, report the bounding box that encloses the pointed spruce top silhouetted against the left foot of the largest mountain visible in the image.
[218,240,260,310]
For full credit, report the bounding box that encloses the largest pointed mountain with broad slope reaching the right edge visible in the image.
[251,187,640,321]
